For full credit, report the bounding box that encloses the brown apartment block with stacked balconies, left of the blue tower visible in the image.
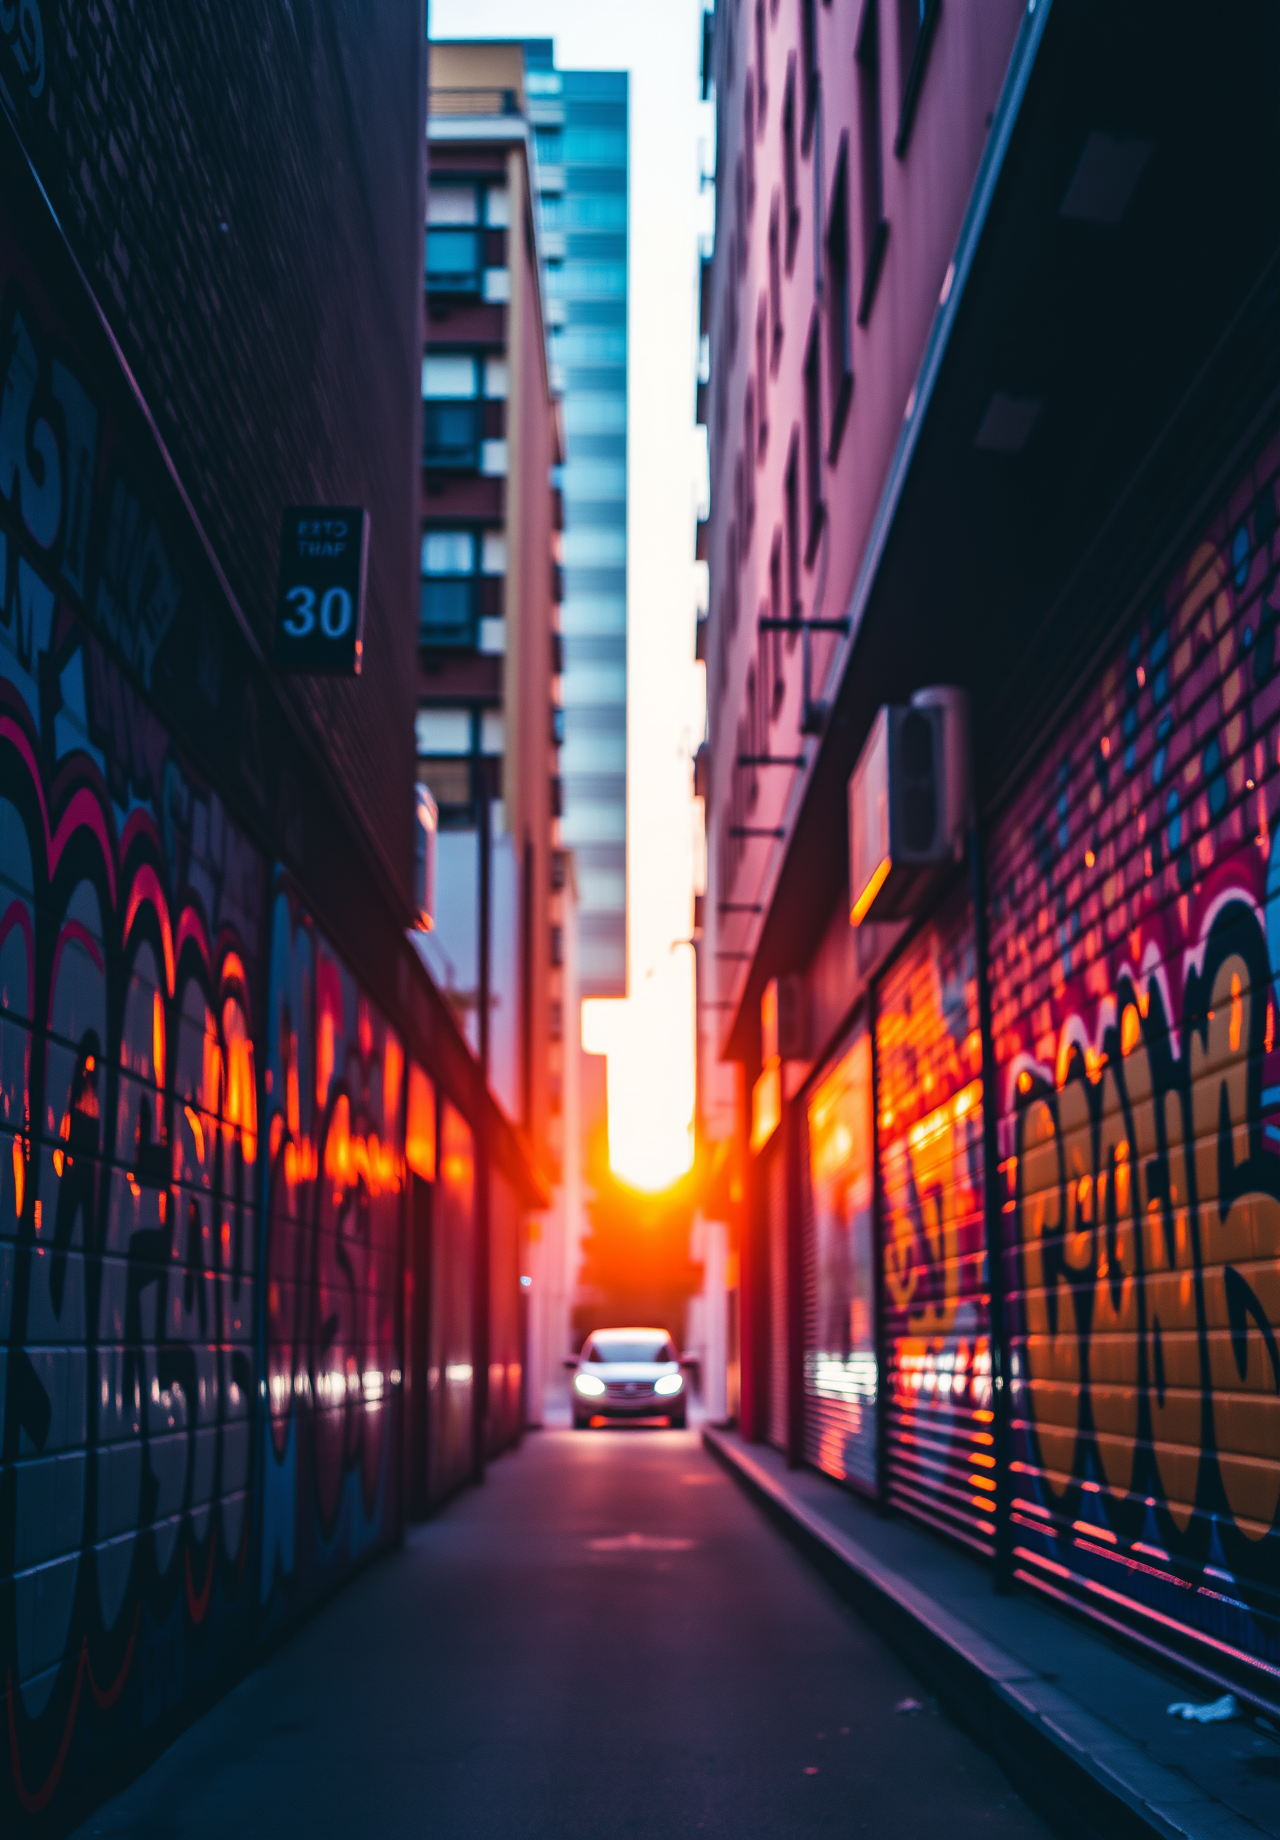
[417,44,568,1172]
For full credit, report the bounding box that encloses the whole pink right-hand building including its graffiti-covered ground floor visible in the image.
[699,0,1280,1708]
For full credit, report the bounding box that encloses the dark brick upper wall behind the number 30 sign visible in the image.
[0,0,425,905]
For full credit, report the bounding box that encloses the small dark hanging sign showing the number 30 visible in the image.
[276,506,370,677]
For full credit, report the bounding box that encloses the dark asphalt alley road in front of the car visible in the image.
[72,1428,1048,1840]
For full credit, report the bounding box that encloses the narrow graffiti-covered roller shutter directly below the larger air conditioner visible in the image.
[875,891,995,1551]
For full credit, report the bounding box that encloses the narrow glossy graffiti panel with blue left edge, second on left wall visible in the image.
[259,876,405,1625]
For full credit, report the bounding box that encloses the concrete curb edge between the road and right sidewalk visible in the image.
[703,1426,1262,1840]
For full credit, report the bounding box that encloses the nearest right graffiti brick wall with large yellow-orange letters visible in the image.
[989,443,1280,1695]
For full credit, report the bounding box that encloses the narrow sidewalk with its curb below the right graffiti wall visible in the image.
[703,1428,1280,1840]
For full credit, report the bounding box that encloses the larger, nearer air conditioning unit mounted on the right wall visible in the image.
[850,684,971,926]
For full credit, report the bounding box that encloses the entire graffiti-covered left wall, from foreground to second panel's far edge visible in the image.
[0,165,403,1831]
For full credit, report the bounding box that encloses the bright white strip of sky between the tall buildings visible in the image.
[430,0,714,1189]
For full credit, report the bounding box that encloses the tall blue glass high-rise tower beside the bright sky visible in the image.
[524,39,629,997]
